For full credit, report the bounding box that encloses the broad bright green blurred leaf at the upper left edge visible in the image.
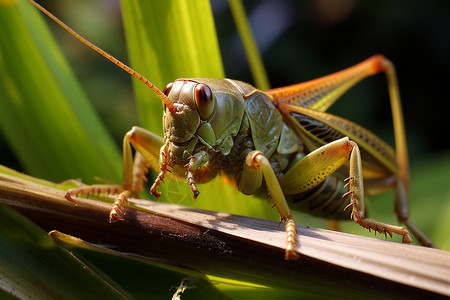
[0,0,120,182]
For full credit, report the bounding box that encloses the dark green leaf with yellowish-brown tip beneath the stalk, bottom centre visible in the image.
[50,231,234,299]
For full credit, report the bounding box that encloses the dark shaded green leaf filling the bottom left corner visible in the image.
[0,205,132,299]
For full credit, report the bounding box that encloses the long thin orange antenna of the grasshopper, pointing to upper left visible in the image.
[28,0,176,113]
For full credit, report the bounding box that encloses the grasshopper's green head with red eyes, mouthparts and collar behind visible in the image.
[156,79,245,197]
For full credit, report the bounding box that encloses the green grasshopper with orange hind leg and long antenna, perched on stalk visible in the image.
[29,0,433,259]
